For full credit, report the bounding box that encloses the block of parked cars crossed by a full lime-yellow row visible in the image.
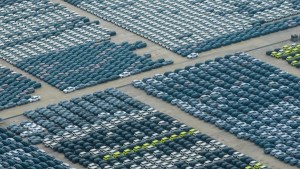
[9,89,267,169]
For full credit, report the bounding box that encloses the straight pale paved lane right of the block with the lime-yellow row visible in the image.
[120,86,297,169]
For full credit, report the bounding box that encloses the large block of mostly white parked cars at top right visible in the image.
[65,0,300,56]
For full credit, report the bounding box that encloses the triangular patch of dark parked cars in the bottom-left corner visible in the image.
[0,128,74,169]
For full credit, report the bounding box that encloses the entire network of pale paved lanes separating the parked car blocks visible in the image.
[0,0,300,169]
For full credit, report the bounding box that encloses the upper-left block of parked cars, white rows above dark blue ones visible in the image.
[0,0,173,93]
